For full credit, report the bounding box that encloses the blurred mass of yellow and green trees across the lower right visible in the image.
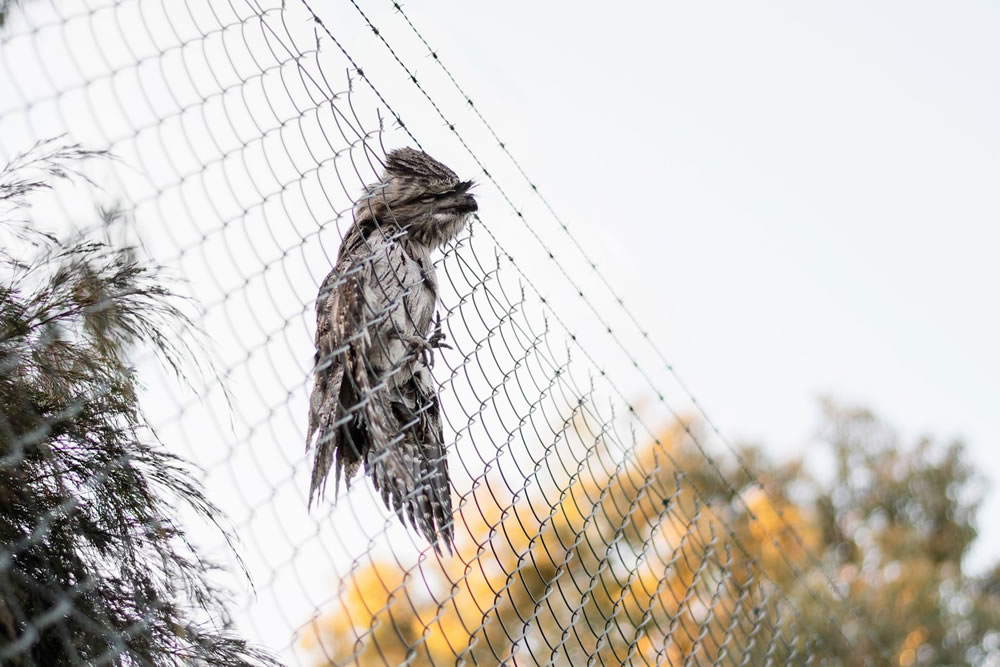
[304,404,1000,665]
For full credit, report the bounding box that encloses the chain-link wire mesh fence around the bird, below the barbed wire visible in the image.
[0,0,892,665]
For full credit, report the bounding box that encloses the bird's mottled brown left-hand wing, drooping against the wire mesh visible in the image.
[306,232,419,512]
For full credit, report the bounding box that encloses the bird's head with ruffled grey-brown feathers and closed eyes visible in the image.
[354,148,479,248]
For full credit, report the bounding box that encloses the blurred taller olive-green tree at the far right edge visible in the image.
[814,404,1000,665]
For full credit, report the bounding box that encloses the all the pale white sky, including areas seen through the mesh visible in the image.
[0,0,1000,660]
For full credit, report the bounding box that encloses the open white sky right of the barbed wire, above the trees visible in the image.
[386,0,1000,563]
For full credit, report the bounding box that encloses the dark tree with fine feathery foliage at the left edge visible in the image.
[0,143,274,666]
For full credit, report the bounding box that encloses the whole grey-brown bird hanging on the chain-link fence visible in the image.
[306,148,477,550]
